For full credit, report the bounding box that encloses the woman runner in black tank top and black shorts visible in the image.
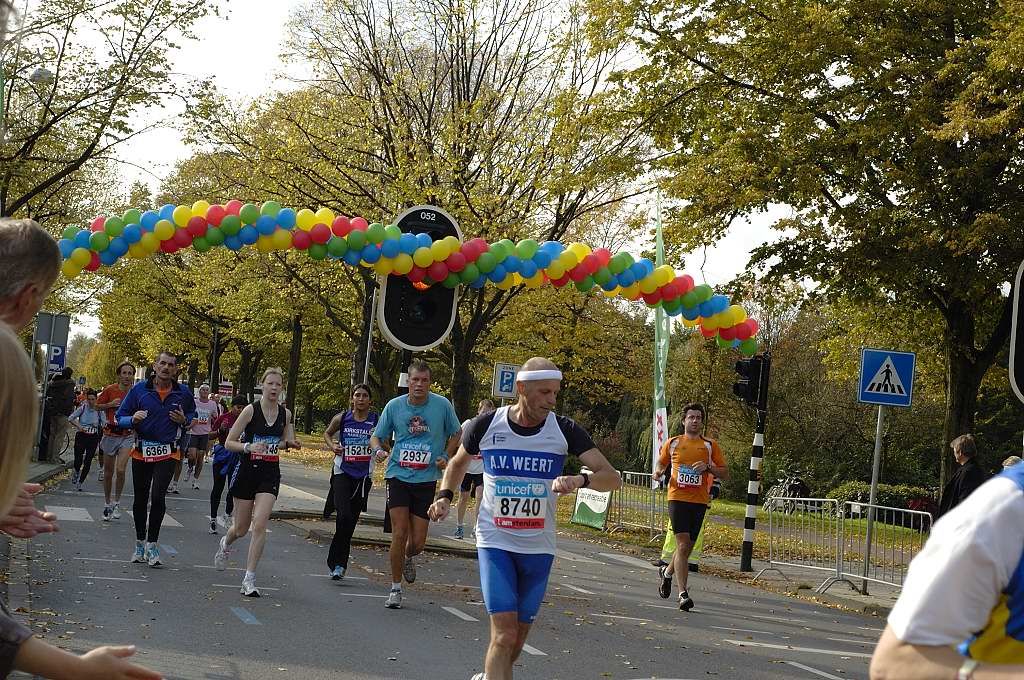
[213,369,302,597]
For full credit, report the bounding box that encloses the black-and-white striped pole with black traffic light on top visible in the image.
[732,353,771,571]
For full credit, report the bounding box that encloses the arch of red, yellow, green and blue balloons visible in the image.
[58,201,759,356]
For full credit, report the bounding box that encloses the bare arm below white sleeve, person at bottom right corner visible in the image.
[870,626,1024,680]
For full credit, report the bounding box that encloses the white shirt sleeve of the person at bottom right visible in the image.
[889,476,1024,646]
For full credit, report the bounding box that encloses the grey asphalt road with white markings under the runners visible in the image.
[12,469,883,680]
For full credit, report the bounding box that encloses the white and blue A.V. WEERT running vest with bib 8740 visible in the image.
[476,407,568,555]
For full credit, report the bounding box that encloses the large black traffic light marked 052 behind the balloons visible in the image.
[377,206,462,351]
